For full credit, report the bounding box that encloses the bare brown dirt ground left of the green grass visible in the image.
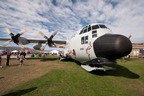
[0,59,68,95]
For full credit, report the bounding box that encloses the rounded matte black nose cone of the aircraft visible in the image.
[93,34,132,59]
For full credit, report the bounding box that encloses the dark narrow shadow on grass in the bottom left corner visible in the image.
[2,87,37,96]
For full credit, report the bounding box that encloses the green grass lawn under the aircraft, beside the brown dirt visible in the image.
[1,59,144,96]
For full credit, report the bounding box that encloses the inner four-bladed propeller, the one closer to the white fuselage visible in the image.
[38,30,58,50]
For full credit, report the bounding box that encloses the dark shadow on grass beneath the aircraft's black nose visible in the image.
[91,64,140,79]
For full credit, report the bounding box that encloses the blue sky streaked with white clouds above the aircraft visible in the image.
[0,0,144,49]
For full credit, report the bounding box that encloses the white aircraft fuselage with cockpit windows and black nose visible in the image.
[62,24,132,64]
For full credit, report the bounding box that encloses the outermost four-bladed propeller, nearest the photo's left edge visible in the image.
[2,27,26,48]
